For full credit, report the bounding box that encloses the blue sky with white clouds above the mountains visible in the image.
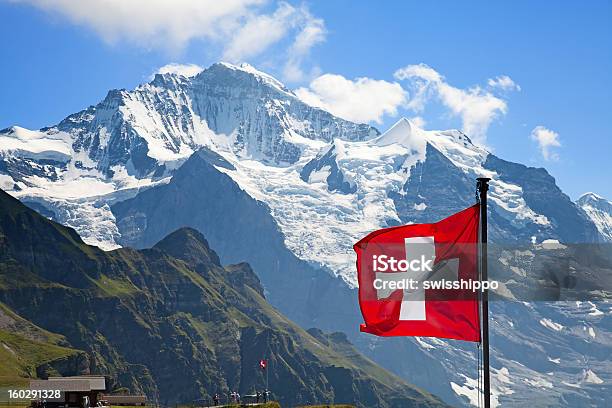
[0,0,612,199]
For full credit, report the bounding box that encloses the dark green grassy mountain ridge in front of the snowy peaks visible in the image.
[0,191,443,407]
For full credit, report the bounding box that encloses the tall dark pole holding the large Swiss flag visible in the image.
[476,177,491,408]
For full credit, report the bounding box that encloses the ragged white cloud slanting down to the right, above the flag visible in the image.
[394,64,514,144]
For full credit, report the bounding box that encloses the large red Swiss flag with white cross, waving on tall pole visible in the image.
[354,204,480,341]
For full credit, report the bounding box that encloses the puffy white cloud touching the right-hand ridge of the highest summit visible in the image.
[295,74,407,123]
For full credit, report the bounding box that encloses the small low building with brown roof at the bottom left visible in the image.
[30,376,107,408]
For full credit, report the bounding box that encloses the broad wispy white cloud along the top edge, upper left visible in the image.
[12,0,325,79]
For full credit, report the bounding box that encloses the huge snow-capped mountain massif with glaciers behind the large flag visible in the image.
[0,63,611,405]
